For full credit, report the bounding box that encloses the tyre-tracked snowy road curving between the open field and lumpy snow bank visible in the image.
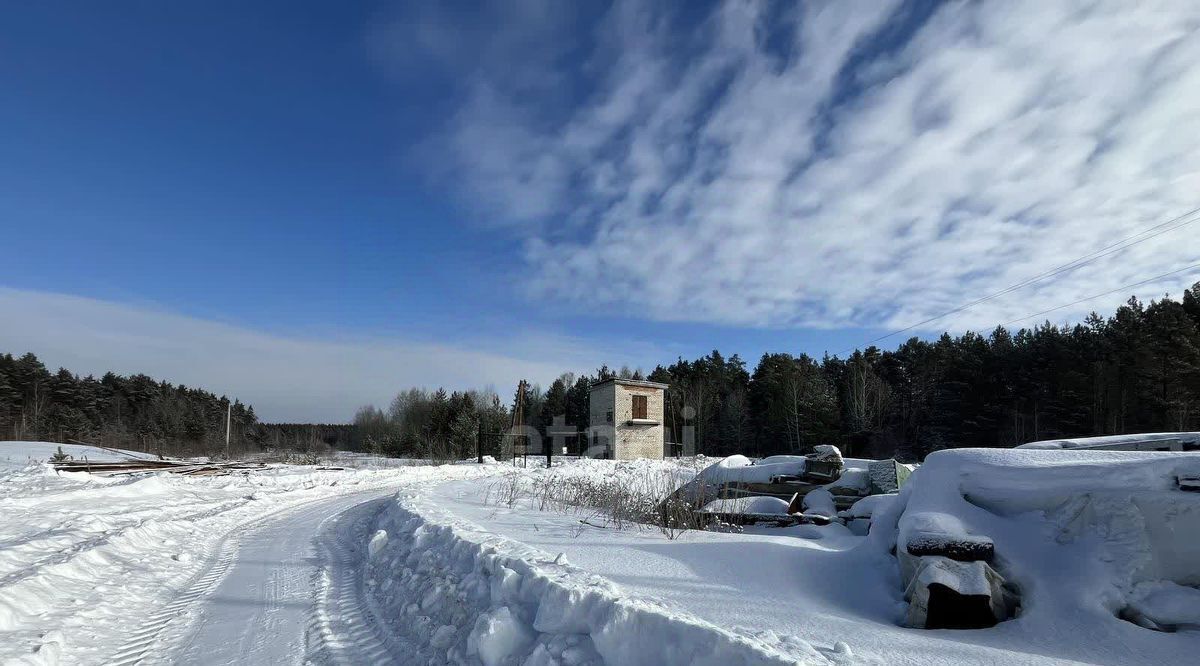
[133,491,402,665]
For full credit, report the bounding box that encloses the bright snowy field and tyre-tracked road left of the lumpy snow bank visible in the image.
[0,442,497,666]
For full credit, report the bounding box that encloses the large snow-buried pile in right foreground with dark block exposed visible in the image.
[870,449,1200,626]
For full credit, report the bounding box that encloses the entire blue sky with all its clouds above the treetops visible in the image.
[0,1,1200,420]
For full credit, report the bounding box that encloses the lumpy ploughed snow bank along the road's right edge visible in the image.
[368,497,829,666]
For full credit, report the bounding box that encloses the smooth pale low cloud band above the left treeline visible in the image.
[0,288,659,422]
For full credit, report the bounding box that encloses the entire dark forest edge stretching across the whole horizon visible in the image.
[0,283,1200,460]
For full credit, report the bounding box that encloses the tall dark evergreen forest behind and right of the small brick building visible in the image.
[355,278,1200,460]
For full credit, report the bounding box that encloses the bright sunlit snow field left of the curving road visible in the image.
[0,442,492,664]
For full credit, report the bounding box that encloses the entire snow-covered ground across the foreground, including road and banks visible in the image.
[0,443,1200,666]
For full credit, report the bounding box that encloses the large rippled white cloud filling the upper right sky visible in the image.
[408,1,1200,328]
